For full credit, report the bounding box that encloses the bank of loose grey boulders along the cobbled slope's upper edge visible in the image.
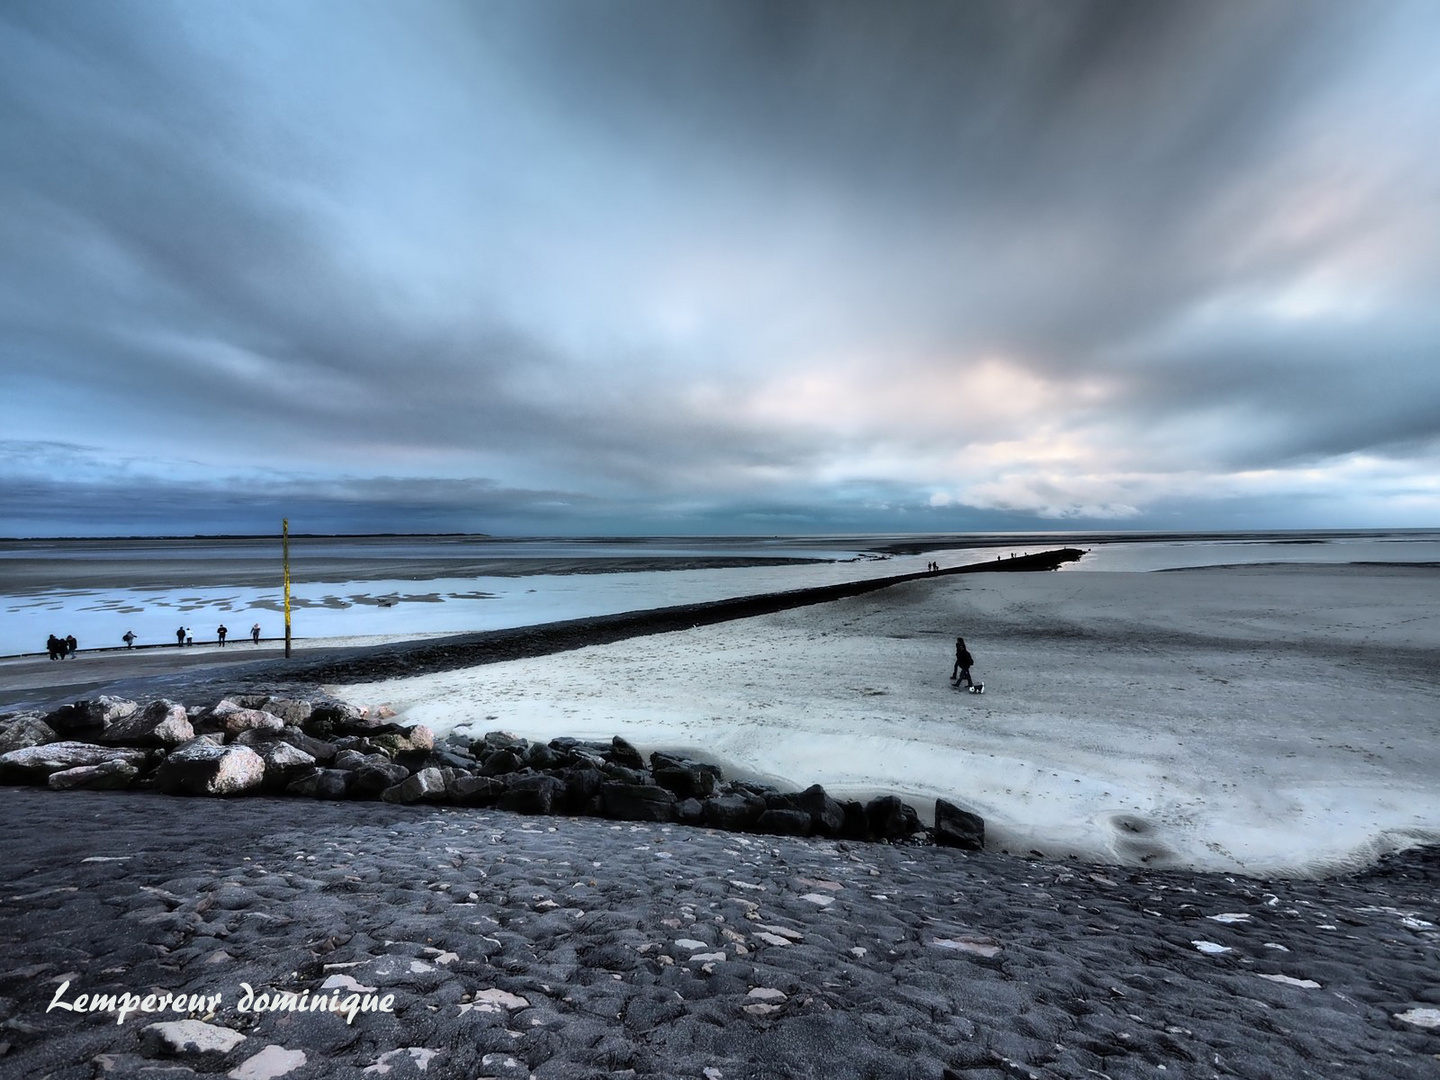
[0,694,985,851]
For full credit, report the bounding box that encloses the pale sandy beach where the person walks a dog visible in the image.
[334,566,1440,874]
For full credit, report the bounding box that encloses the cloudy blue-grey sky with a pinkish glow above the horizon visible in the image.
[0,0,1440,536]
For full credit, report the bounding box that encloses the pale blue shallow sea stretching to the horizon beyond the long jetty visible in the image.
[0,531,1440,655]
